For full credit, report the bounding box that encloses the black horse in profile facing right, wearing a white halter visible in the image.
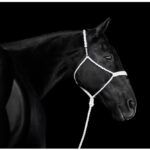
[0,19,137,147]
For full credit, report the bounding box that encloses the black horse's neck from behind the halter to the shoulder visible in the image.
[1,31,85,98]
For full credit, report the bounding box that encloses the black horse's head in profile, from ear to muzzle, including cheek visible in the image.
[75,18,137,121]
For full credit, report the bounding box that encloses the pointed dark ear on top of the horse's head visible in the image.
[96,17,111,35]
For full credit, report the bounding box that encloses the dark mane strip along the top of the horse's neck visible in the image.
[0,31,79,50]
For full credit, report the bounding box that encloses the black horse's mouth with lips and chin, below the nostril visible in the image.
[118,107,136,121]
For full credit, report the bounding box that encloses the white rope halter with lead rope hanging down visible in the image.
[74,30,127,149]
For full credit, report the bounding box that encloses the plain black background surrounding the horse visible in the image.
[0,3,150,148]
